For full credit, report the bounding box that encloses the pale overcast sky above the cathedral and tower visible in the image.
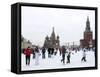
[21,6,95,46]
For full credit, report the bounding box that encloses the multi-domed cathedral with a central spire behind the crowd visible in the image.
[43,27,60,48]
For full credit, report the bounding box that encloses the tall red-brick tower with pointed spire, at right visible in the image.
[80,17,95,48]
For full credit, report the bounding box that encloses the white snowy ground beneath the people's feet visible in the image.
[21,51,95,71]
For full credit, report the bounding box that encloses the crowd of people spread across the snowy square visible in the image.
[23,46,94,66]
